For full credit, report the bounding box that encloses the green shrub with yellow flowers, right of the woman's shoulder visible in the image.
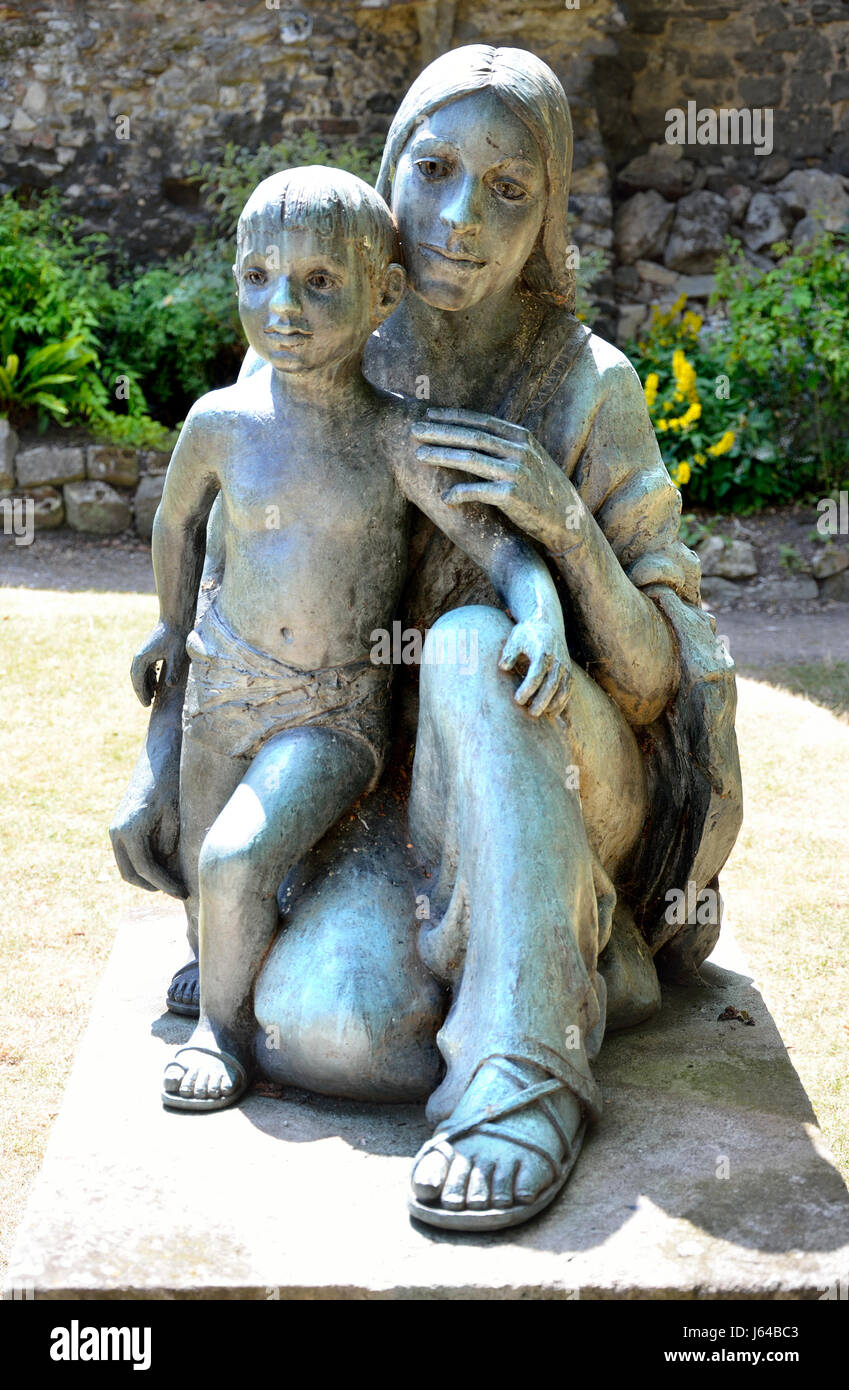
[627,234,849,512]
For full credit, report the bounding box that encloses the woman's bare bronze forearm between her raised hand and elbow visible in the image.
[550,489,678,724]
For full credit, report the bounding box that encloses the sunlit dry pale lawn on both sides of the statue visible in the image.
[0,589,849,1273]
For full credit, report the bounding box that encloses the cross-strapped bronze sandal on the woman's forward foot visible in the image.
[407,1058,586,1230]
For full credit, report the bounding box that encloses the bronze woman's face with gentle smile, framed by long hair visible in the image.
[392,89,546,310]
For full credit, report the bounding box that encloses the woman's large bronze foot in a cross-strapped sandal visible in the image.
[411,1058,584,1226]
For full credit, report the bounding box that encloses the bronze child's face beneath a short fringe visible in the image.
[233,209,384,373]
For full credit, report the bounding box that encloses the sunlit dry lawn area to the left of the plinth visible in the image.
[0,589,157,1258]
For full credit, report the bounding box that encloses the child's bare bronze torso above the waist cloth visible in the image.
[215,373,409,670]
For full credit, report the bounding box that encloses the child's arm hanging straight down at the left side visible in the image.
[132,406,221,705]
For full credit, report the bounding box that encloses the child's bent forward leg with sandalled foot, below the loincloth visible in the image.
[165,728,374,1101]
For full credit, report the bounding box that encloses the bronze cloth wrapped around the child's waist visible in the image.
[183,603,392,785]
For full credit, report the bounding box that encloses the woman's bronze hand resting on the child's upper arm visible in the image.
[413,410,582,555]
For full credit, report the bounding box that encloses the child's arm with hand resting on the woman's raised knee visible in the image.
[396,430,570,716]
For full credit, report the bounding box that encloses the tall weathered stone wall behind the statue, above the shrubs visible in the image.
[0,0,849,339]
